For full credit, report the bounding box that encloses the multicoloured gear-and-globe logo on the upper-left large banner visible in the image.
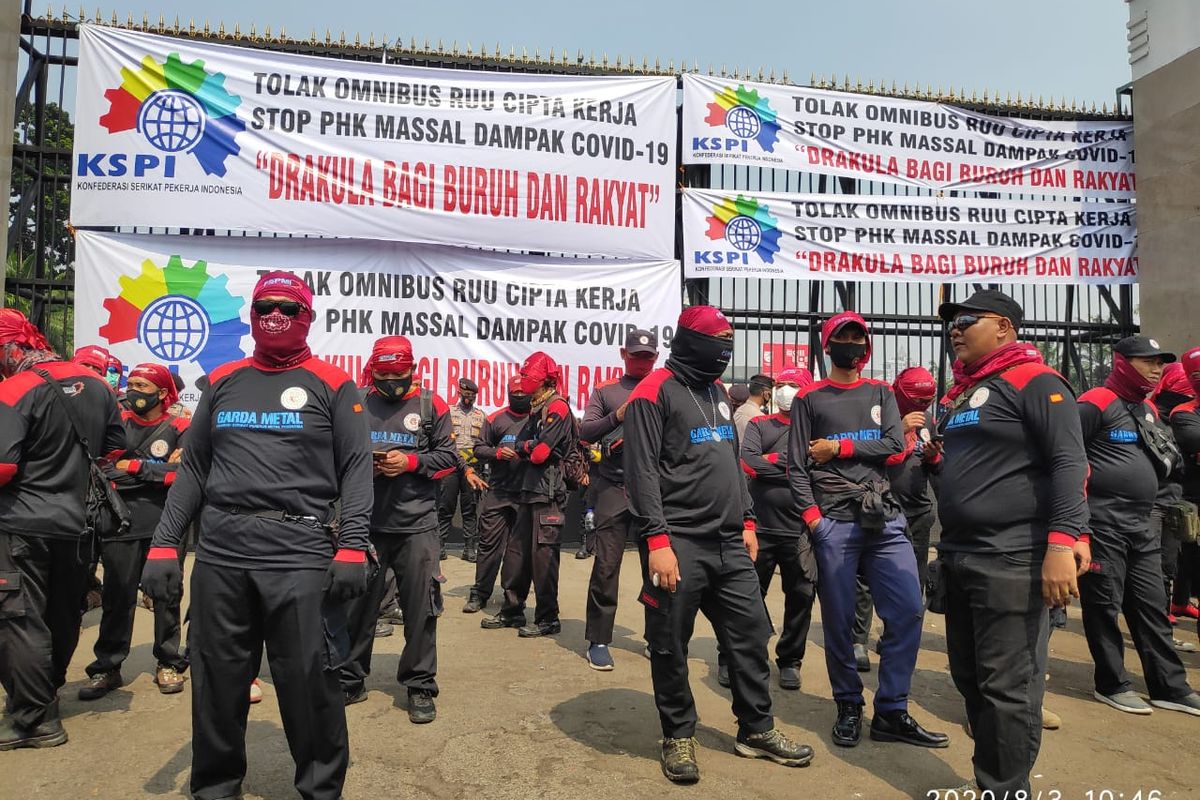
[100,53,246,176]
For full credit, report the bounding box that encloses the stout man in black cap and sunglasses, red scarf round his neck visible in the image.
[934,289,1090,798]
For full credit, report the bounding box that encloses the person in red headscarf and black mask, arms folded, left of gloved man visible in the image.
[76,362,187,700]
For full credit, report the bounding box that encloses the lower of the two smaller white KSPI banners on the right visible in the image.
[683,188,1138,283]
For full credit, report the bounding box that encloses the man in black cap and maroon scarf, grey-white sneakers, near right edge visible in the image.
[1079,336,1200,716]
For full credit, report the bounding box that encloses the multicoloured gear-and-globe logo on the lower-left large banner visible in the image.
[100,255,250,373]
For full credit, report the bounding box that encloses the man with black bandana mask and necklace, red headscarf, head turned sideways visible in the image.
[624,306,812,783]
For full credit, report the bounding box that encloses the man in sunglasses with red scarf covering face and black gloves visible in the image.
[142,272,372,800]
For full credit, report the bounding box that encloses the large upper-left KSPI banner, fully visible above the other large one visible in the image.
[71,25,676,258]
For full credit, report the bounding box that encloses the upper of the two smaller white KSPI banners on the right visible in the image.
[683,74,1136,198]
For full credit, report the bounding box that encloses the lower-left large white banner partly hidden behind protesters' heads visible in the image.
[74,230,682,410]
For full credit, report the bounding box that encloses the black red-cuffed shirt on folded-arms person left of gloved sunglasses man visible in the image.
[106,409,188,540]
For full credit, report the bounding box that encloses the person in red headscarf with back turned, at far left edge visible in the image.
[0,308,125,750]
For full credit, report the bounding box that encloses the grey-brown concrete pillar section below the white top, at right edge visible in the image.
[1133,49,1200,350]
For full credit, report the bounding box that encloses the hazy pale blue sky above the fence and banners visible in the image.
[79,0,1129,106]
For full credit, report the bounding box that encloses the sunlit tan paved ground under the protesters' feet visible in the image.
[0,552,1200,800]
